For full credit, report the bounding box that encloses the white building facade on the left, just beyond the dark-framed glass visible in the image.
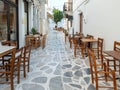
[18,0,48,47]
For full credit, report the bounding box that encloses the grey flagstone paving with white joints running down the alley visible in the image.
[0,30,120,90]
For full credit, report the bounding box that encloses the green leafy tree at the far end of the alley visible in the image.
[53,8,63,25]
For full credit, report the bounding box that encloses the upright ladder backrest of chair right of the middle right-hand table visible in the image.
[97,38,103,59]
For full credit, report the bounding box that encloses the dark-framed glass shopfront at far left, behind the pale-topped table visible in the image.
[0,0,18,41]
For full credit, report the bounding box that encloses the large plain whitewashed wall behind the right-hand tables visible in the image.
[73,0,120,49]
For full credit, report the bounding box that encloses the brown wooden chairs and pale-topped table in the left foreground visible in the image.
[0,41,31,90]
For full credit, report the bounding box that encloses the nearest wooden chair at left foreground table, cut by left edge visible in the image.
[0,48,16,90]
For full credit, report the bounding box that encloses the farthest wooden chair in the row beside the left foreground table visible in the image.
[20,45,31,78]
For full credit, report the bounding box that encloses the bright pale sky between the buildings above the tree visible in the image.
[48,0,65,11]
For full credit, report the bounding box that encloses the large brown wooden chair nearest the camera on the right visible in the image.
[88,49,117,90]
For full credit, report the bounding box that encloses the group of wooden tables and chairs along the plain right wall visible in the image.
[68,34,120,90]
